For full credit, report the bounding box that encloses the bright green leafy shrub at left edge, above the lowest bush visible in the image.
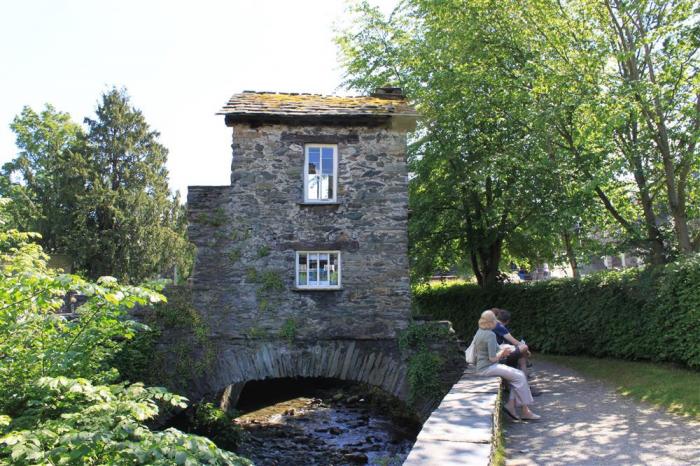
[0,230,163,415]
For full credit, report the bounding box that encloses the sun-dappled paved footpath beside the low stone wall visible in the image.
[503,359,700,466]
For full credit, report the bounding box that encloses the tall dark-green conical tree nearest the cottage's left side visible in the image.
[76,89,192,282]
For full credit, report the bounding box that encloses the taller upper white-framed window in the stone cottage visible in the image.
[304,144,338,203]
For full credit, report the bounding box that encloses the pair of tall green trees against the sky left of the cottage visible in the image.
[0,89,194,283]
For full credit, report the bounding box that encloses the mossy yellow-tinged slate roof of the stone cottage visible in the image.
[217,91,418,117]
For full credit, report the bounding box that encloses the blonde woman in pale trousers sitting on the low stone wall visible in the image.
[473,311,540,421]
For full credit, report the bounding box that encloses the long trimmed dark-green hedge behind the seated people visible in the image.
[415,255,700,368]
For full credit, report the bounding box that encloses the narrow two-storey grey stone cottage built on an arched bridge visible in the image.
[188,88,438,404]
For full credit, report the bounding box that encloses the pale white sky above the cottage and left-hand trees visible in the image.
[0,0,396,195]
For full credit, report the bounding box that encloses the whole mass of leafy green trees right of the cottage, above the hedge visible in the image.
[337,0,700,276]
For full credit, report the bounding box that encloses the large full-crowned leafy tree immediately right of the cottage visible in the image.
[338,0,573,285]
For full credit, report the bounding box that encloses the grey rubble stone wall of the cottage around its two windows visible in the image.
[188,124,410,341]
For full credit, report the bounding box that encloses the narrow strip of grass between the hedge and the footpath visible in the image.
[538,354,700,419]
